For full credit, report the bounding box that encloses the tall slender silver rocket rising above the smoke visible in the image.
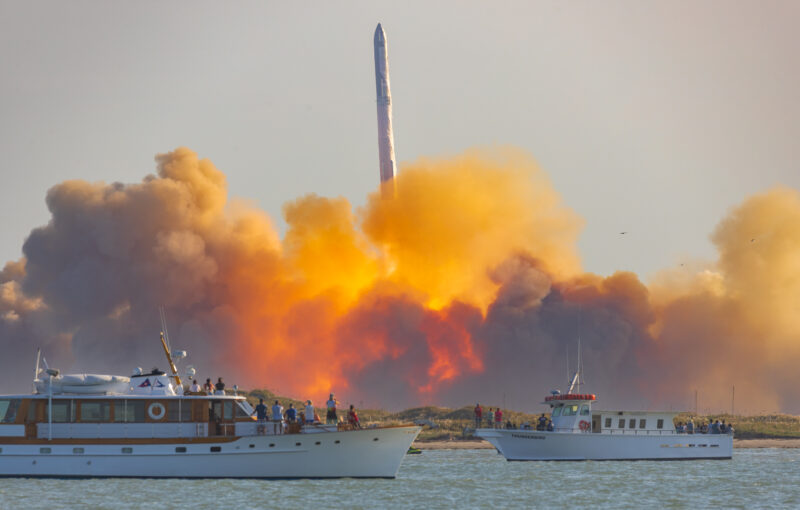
[374,23,397,198]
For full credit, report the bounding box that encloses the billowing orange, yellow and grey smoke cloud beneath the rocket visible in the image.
[0,149,800,411]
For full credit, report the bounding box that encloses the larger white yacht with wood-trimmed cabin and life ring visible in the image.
[0,337,420,478]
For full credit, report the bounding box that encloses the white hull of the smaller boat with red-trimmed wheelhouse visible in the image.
[476,429,733,460]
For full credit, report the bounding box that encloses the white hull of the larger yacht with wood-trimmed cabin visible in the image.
[0,426,420,478]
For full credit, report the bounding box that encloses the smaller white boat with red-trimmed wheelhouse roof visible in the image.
[476,373,733,460]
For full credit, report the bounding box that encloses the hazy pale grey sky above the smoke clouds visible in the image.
[0,0,800,277]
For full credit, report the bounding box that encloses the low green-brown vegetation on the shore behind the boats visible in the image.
[244,389,800,441]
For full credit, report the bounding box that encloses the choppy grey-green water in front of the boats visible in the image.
[0,449,800,510]
